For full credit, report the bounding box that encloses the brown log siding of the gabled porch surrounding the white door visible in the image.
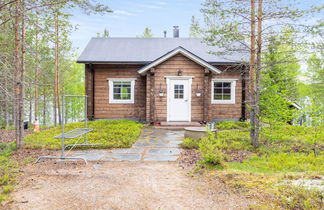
[154,54,204,121]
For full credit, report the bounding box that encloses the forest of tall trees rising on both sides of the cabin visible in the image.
[0,0,324,148]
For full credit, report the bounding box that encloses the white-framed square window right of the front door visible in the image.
[212,79,236,104]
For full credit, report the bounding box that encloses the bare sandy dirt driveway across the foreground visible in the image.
[10,161,249,209]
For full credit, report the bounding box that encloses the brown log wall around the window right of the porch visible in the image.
[208,66,242,121]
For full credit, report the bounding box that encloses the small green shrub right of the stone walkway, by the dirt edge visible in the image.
[199,132,227,167]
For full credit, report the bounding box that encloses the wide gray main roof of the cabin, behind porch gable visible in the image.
[77,38,244,63]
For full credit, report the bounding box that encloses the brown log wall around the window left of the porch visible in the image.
[94,64,146,120]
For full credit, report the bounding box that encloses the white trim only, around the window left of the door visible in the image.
[107,78,136,104]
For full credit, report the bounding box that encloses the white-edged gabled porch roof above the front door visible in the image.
[137,46,222,75]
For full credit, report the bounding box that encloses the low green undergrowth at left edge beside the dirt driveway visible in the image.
[0,143,18,203]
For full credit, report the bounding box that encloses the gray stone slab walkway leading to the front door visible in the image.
[72,129,184,161]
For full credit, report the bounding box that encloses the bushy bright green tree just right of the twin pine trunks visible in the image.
[260,28,300,124]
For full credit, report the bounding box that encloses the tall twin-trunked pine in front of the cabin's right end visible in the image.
[201,0,316,147]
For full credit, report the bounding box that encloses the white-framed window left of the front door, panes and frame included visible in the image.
[108,78,136,104]
